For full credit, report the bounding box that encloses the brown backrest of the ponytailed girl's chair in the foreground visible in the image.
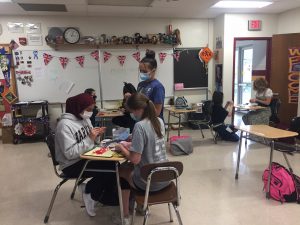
[141,161,183,182]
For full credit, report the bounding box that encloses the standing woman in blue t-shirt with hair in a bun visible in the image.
[137,50,165,120]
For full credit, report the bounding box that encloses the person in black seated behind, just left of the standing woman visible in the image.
[112,82,136,133]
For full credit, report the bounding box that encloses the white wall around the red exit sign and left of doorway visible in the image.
[223,14,277,104]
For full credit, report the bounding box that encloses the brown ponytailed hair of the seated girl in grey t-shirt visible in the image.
[126,93,163,138]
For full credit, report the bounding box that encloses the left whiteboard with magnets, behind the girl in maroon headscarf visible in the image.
[16,50,100,103]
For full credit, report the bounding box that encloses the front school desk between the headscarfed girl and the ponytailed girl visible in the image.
[76,149,125,225]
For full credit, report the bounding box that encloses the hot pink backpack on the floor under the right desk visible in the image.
[262,162,297,202]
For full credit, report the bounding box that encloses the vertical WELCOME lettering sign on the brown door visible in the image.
[288,48,300,104]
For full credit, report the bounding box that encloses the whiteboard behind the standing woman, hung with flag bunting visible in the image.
[100,48,174,100]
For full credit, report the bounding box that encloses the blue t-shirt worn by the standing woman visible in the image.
[137,79,165,120]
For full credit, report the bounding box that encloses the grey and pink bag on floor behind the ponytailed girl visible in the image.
[170,136,193,156]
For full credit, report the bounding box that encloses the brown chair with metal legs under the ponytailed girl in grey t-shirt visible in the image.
[131,162,183,225]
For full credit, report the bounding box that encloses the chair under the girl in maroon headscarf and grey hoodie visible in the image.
[44,132,85,223]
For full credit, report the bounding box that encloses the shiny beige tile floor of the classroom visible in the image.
[0,128,300,225]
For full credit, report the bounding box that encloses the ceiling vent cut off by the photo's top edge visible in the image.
[88,0,154,7]
